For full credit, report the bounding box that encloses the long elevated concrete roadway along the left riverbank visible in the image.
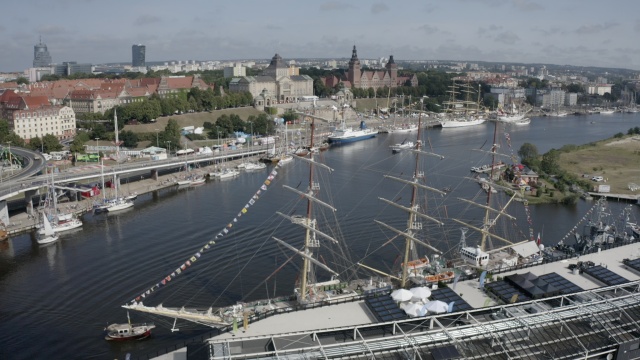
[0,149,267,224]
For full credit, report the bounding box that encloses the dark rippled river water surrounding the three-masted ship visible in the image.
[0,114,640,359]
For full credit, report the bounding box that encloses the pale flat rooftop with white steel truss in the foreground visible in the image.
[189,243,640,359]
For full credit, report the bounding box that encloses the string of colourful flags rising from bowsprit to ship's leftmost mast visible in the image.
[131,166,279,303]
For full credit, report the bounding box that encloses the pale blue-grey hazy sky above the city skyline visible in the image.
[0,0,640,72]
